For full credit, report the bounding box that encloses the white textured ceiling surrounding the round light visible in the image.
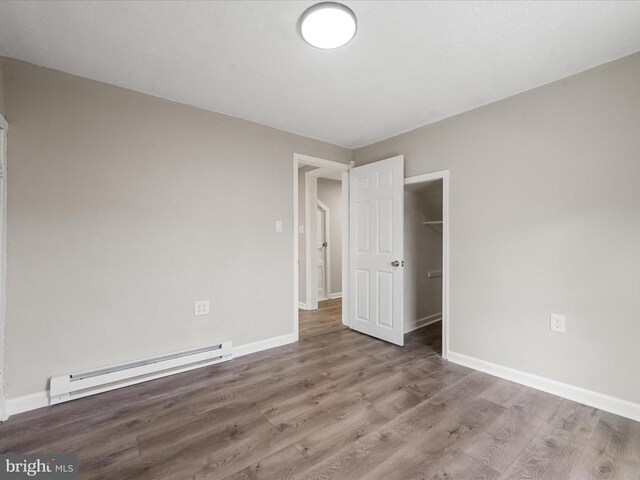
[0,1,640,147]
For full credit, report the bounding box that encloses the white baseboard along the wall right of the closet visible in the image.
[448,351,640,422]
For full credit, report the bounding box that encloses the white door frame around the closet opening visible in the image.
[404,170,451,360]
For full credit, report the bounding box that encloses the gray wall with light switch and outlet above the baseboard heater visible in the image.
[4,60,352,398]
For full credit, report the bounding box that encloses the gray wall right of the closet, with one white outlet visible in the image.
[355,54,640,402]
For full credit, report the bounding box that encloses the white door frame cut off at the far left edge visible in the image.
[0,114,9,422]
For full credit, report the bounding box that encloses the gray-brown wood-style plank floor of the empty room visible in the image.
[0,300,640,480]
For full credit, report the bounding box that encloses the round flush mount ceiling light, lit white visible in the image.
[300,2,357,50]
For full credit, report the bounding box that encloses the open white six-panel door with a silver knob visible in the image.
[349,155,404,346]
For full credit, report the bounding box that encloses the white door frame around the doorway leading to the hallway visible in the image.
[292,153,353,342]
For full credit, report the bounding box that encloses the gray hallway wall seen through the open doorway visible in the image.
[318,178,343,294]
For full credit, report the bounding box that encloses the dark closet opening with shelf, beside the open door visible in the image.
[404,177,446,355]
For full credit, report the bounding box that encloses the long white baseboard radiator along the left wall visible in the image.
[49,342,233,405]
